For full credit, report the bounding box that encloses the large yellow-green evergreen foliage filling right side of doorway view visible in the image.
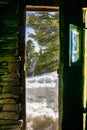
[26,12,59,75]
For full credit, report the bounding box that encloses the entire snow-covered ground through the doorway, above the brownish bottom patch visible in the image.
[26,72,58,130]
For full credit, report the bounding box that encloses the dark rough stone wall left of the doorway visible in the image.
[0,0,23,130]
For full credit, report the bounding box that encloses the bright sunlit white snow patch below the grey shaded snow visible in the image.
[26,102,58,119]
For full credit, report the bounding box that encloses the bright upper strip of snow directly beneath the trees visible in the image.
[26,72,58,88]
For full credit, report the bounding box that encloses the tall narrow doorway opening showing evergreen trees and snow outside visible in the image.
[25,6,60,130]
